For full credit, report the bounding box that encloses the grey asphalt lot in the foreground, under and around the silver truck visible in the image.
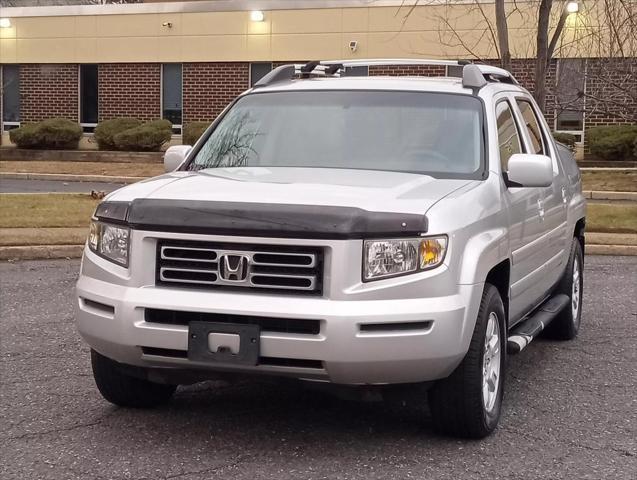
[0,257,637,480]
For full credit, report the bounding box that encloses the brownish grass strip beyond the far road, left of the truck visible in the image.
[0,161,164,177]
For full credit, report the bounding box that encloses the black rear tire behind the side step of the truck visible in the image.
[544,238,584,340]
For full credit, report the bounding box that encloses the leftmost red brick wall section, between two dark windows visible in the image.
[20,63,79,122]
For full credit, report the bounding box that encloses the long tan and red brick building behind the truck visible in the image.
[0,0,637,150]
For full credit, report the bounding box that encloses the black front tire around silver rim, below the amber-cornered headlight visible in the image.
[428,283,507,438]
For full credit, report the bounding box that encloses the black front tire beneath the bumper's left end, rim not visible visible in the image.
[91,350,177,408]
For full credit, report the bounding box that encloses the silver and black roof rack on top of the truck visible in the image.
[254,58,518,93]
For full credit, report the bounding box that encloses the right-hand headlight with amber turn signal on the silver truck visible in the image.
[363,236,447,281]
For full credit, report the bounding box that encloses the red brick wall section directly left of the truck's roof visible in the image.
[183,62,250,124]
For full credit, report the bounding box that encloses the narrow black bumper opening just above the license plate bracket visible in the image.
[144,308,321,335]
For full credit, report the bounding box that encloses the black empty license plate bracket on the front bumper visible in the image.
[188,321,260,365]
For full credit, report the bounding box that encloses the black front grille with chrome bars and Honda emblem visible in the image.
[156,240,323,294]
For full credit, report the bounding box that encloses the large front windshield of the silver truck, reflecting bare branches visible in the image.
[186,91,483,178]
